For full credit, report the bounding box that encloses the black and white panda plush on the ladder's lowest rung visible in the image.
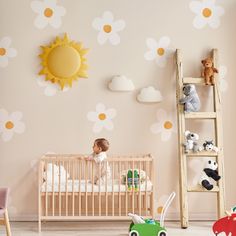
[199,160,221,190]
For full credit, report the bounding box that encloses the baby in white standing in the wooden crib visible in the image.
[86,138,111,185]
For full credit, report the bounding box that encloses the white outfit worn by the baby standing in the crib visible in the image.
[92,152,111,185]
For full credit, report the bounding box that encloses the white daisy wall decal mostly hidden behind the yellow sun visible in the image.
[36,76,69,97]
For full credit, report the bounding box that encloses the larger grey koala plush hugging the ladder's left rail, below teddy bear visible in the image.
[179,84,201,112]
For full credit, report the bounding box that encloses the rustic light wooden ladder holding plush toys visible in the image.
[176,49,225,228]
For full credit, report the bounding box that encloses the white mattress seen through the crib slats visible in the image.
[41,180,152,193]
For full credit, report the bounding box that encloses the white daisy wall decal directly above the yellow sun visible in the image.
[31,0,66,29]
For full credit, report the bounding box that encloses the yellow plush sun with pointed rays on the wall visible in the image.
[39,34,88,89]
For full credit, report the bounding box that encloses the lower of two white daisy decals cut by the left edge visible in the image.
[0,109,25,142]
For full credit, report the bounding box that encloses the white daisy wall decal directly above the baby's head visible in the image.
[87,103,116,133]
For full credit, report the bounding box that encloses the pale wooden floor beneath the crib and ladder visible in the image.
[0,222,218,236]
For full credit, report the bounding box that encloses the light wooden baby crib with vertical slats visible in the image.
[38,154,155,231]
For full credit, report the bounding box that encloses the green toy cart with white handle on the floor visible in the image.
[128,192,176,236]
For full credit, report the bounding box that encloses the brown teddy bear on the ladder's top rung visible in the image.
[202,58,218,85]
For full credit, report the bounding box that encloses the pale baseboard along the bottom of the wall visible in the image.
[10,212,217,222]
